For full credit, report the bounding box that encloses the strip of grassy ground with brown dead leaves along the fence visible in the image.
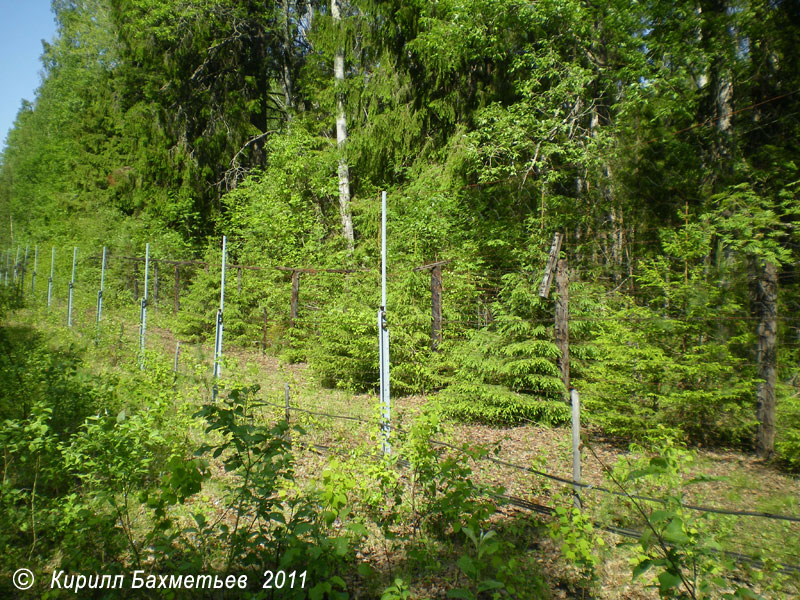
[10,296,800,599]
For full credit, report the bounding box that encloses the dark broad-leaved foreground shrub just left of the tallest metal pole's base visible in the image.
[184,388,363,598]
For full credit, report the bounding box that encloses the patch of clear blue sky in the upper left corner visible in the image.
[0,0,56,147]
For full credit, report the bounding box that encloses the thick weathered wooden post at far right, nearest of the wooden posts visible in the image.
[750,259,778,459]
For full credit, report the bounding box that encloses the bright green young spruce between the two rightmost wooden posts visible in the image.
[576,224,755,446]
